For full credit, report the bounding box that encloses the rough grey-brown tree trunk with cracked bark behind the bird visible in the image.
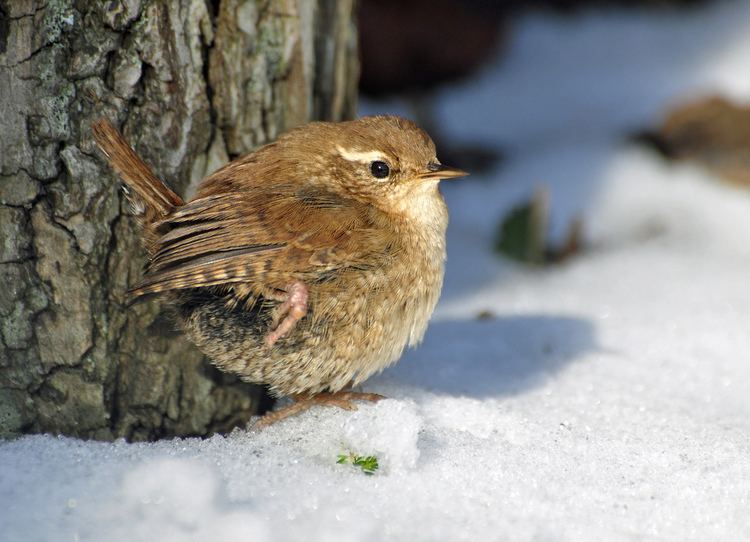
[0,0,357,440]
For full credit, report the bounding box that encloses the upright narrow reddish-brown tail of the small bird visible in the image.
[91,119,185,220]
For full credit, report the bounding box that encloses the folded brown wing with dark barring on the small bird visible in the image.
[130,187,386,297]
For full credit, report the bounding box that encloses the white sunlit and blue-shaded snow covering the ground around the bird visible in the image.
[0,2,750,541]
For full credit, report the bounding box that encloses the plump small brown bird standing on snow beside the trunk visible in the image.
[92,116,466,424]
